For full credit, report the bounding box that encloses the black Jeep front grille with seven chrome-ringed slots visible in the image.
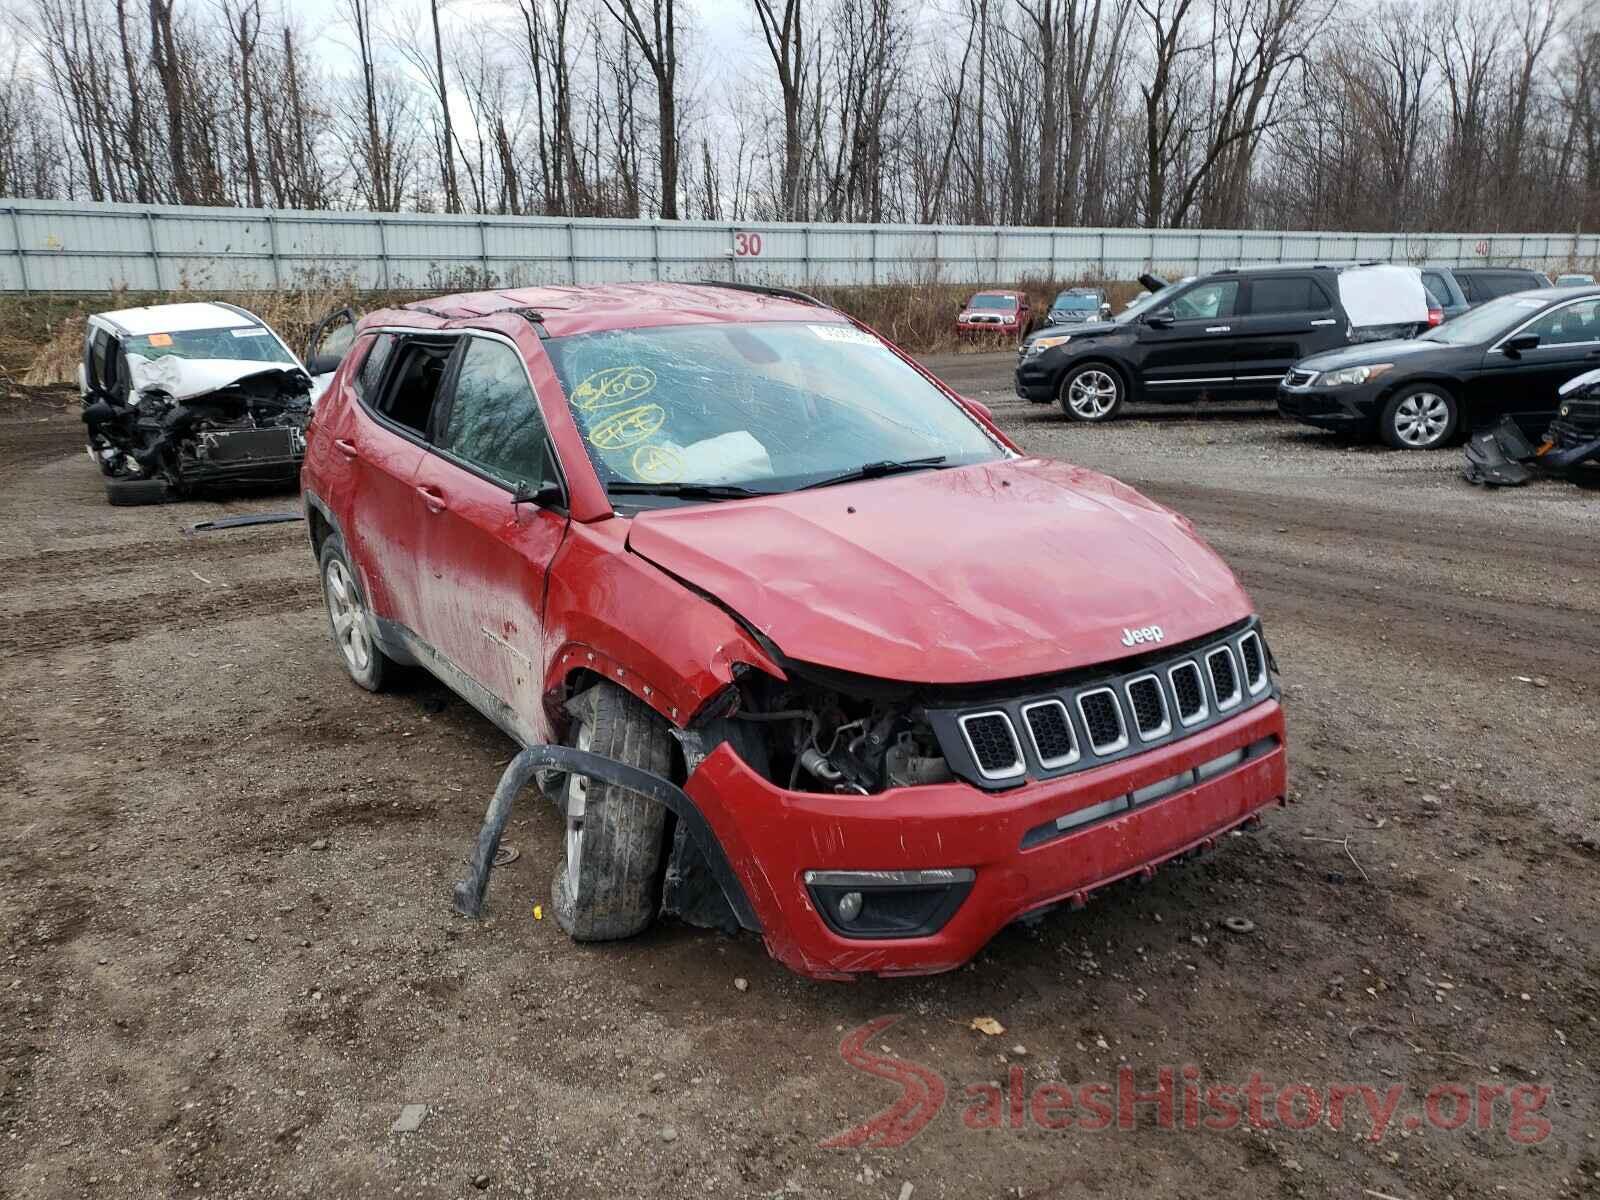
[925,621,1277,789]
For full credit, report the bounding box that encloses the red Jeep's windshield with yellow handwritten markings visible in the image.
[544,323,1005,493]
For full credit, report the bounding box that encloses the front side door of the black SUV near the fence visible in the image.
[1138,278,1238,402]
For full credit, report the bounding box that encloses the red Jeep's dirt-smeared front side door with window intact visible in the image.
[416,333,566,744]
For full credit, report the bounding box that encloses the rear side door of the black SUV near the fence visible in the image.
[1234,272,1346,397]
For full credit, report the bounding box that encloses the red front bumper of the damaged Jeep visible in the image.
[685,699,1288,979]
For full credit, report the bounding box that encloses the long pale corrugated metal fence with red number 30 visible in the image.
[0,200,1600,291]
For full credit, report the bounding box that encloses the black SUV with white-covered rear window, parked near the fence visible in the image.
[1016,264,1426,421]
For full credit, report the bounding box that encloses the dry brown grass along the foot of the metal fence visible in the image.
[0,278,1138,387]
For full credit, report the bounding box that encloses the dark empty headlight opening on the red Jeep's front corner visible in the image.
[731,672,955,795]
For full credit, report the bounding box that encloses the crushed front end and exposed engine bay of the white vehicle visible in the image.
[83,355,312,499]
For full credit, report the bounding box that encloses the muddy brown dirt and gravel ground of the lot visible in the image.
[0,364,1600,1200]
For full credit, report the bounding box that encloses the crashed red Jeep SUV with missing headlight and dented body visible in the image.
[304,283,1285,978]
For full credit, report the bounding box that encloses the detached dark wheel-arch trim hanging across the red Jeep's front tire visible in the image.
[454,746,762,933]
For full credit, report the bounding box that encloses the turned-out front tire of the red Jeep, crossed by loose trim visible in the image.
[550,683,672,942]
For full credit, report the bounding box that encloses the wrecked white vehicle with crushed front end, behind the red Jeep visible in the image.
[78,302,326,506]
